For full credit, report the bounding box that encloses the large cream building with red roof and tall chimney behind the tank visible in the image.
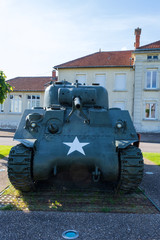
[55,28,160,133]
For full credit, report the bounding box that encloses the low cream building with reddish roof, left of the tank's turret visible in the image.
[0,71,57,129]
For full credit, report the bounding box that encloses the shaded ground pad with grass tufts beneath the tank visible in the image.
[0,169,158,213]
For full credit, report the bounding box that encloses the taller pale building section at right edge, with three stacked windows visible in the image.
[134,41,160,132]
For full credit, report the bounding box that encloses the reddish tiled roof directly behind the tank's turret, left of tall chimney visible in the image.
[54,50,133,69]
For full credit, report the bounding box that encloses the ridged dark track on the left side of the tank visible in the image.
[8,144,34,192]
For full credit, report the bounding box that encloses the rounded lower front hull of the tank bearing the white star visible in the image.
[33,135,119,181]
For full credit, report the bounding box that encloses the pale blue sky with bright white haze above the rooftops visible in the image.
[0,0,160,79]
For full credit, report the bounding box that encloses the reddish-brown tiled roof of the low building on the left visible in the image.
[7,77,52,92]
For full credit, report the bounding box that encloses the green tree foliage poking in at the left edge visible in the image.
[0,71,13,104]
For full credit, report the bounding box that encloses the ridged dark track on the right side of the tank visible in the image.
[117,146,144,192]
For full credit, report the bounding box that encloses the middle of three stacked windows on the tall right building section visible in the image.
[146,70,157,89]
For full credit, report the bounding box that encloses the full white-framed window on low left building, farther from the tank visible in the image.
[10,95,22,113]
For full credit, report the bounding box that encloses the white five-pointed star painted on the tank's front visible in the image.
[63,137,90,155]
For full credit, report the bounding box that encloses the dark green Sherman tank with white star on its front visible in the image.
[8,81,143,191]
